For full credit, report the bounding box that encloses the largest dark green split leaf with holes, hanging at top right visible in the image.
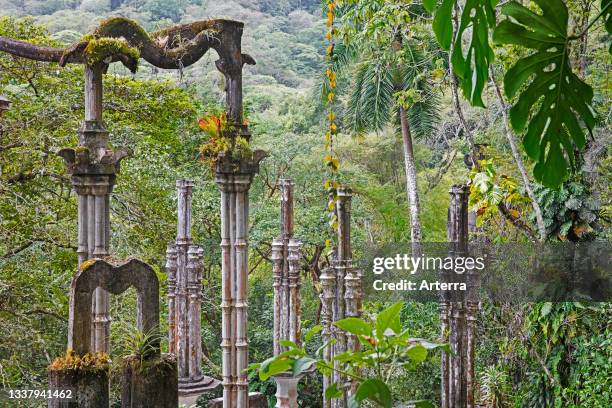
[493,0,595,187]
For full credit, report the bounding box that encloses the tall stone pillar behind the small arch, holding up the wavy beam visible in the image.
[58,63,127,353]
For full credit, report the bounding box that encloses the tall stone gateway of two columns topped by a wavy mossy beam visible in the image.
[0,17,265,408]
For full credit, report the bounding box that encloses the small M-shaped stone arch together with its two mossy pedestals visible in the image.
[49,259,178,408]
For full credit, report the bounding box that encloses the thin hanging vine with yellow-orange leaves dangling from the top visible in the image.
[324,0,340,237]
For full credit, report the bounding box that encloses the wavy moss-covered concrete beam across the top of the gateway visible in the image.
[0,17,255,70]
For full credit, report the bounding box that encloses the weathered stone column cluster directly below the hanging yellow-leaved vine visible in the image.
[319,188,363,408]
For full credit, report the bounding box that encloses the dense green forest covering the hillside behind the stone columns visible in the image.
[0,0,612,408]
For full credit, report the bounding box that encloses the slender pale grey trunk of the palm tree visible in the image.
[399,106,422,244]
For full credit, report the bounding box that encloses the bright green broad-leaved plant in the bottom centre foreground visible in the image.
[250,302,449,408]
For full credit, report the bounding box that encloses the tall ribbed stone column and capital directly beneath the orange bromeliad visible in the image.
[215,147,265,408]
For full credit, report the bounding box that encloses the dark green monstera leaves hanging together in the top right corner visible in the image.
[423,0,612,187]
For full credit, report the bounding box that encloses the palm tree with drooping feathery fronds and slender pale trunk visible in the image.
[345,42,439,243]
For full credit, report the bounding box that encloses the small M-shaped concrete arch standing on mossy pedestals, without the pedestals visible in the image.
[68,259,159,355]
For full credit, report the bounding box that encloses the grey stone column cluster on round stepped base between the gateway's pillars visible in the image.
[166,180,219,397]
